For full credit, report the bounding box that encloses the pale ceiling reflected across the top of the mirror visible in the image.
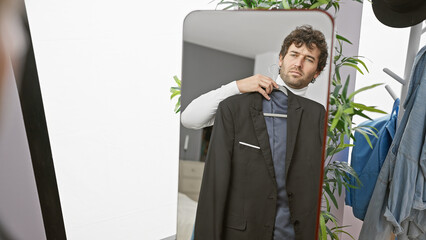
[183,10,334,58]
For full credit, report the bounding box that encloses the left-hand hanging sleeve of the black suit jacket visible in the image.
[194,102,234,240]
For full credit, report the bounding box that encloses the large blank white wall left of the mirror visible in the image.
[26,0,215,240]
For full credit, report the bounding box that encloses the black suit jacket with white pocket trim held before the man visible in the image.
[194,91,325,240]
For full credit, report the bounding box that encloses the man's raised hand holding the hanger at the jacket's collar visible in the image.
[237,74,278,100]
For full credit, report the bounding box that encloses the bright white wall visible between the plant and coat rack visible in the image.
[355,5,426,123]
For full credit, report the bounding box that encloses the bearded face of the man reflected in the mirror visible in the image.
[279,43,320,89]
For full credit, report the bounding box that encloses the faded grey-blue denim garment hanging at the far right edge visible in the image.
[359,46,426,240]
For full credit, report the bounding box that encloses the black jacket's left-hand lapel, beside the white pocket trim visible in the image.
[250,94,276,185]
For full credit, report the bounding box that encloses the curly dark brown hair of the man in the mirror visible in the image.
[280,25,328,72]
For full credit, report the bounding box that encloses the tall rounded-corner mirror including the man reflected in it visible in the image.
[177,11,333,240]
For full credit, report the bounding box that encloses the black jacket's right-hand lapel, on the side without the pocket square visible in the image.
[285,91,303,178]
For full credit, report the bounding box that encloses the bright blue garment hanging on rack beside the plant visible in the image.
[345,99,399,220]
